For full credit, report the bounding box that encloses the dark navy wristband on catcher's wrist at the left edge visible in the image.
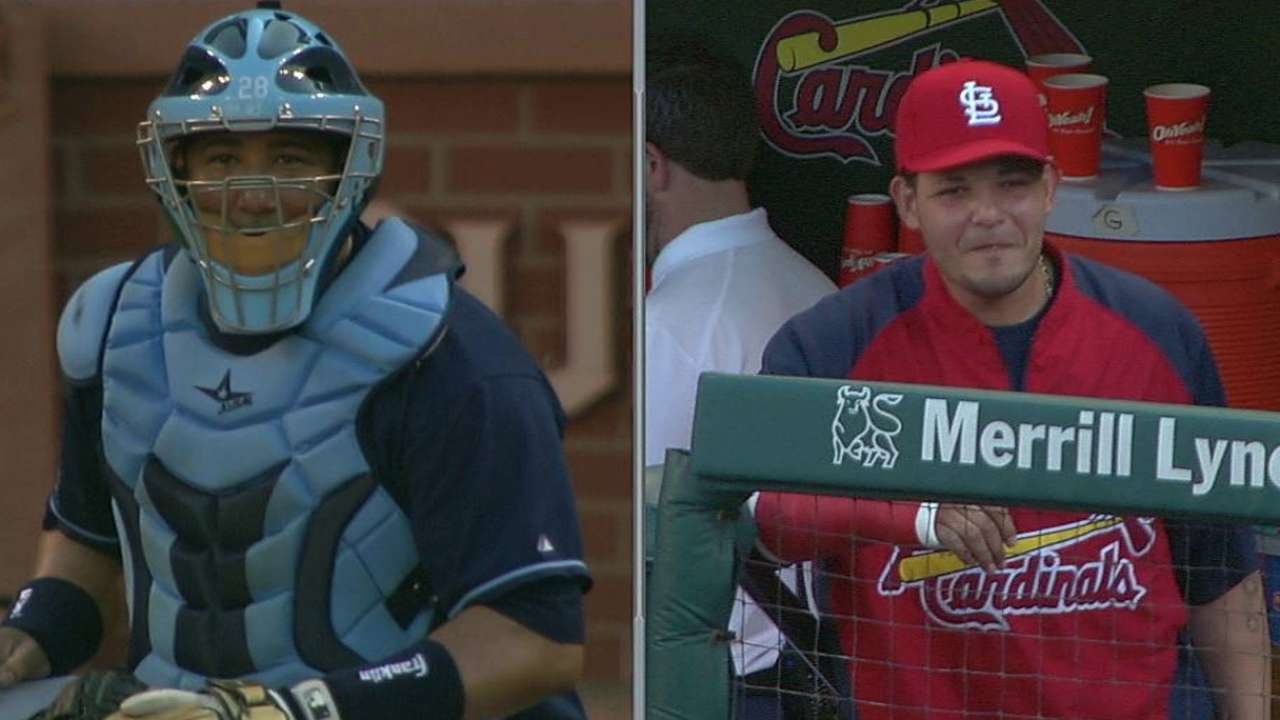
[3,578,102,675]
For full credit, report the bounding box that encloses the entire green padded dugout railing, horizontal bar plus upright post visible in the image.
[645,373,1280,720]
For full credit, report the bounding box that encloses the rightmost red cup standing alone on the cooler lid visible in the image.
[1142,82,1210,190]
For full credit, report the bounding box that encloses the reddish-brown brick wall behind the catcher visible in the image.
[51,71,632,683]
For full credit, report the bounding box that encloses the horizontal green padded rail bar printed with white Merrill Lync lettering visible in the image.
[692,373,1280,524]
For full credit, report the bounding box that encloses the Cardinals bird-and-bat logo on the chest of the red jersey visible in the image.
[877,515,1156,630]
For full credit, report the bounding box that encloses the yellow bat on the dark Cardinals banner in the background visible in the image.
[778,0,1000,72]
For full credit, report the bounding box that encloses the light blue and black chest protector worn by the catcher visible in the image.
[94,220,452,687]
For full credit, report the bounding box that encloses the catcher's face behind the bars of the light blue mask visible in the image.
[177,131,340,275]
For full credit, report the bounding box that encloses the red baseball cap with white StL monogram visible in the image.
[893,60,1050,173]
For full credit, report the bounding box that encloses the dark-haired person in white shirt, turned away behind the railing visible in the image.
[644,41,836,720]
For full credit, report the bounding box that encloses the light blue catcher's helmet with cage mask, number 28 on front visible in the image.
[138,4,385,333]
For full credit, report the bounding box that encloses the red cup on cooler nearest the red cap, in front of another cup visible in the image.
[1044,73,1107,179]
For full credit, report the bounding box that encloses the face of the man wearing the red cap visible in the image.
[891,159,1057,301]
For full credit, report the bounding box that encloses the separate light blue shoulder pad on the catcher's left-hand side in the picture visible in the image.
[58,257,133,383]
